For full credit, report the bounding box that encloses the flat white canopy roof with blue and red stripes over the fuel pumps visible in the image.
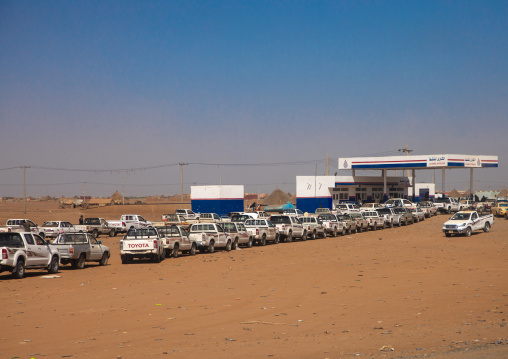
[339,154,498,170]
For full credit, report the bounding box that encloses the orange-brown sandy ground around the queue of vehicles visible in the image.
[0,203,508,359]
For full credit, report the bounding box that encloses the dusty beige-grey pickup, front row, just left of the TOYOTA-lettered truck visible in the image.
[51,233,110,269]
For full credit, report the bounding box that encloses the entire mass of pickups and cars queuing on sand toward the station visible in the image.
[0,200,500,278]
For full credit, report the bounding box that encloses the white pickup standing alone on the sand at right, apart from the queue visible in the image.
[443,211,494,237]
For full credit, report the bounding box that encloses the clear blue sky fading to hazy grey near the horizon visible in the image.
[0,0,508,196]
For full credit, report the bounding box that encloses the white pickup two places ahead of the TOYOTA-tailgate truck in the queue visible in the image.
[189,223,233,253]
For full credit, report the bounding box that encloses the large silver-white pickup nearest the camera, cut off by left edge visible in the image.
[0,232,60,279]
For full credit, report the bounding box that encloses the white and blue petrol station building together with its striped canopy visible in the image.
[296,154,498,212]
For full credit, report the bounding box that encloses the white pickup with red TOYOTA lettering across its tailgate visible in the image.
[120,227,165,264]
